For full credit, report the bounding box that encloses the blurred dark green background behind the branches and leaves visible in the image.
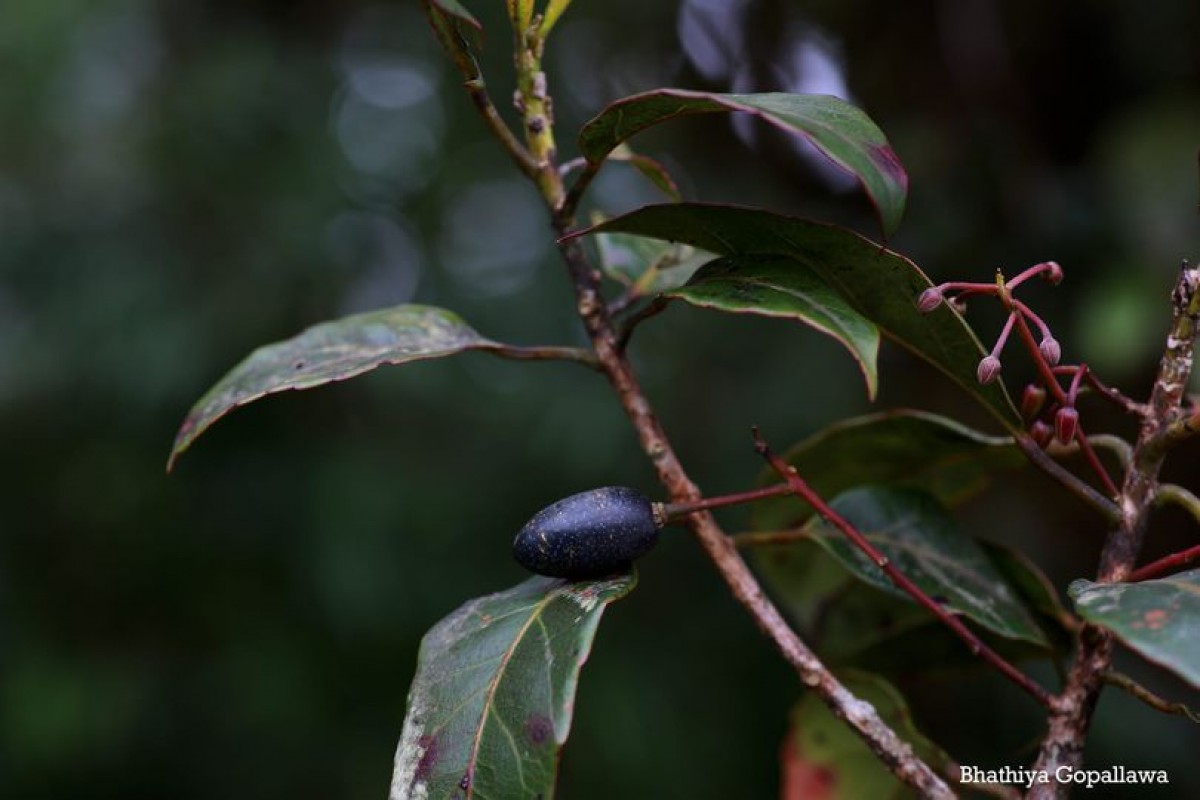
[0,0,1200,799]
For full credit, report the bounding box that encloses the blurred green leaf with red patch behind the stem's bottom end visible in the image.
[780,672,950,800]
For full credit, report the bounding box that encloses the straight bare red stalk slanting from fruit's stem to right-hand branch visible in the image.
[754,428,1051,708]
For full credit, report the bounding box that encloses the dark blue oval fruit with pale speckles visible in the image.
[512,486,659,581]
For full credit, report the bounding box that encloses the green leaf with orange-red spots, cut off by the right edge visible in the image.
[1068,570,1200,687]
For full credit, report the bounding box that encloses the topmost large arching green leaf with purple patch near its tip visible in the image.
[580,89,908,234]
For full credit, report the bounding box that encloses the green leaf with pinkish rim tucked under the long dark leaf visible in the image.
[666,255,880,399]
